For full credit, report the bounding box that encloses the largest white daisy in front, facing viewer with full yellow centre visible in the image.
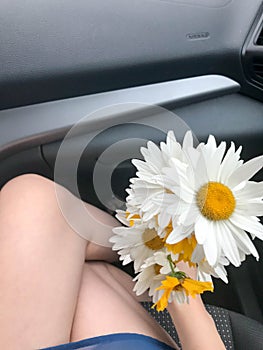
[164,136,263,266]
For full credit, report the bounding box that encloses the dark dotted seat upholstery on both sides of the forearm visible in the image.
[142,302,263,350]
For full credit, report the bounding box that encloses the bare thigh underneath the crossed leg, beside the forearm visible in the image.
[71,262,179,347]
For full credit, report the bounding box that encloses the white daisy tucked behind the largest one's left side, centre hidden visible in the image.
[126,131,192,227]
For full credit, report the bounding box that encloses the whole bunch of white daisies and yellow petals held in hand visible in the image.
[110,131,263,311]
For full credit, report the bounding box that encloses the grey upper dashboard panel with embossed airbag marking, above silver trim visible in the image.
[0,0,262,109]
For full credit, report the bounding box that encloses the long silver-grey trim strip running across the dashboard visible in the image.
[0,75,240,159]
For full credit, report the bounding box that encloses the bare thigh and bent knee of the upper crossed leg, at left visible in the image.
[0,175,101,350]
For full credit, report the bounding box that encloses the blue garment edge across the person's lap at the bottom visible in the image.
[41,333,177,350]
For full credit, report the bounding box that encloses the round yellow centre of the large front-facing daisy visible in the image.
[196,182,236,221]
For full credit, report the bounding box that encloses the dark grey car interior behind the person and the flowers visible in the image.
[0,0,263,350]
